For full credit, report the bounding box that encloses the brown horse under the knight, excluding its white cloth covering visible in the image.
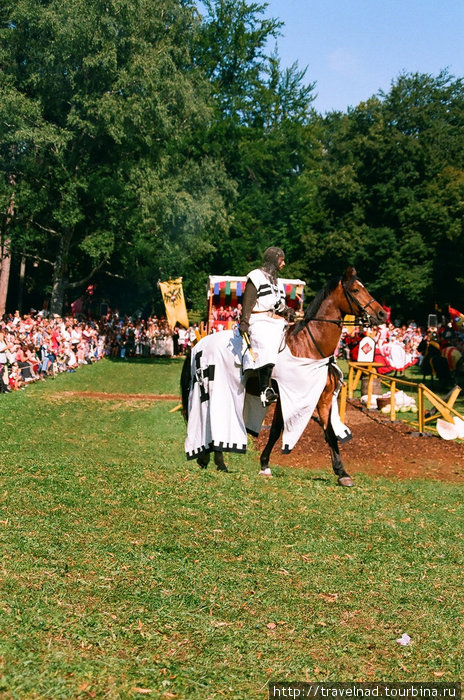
[181,267,387,486]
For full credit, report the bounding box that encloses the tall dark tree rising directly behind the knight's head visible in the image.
[196,0,318,274]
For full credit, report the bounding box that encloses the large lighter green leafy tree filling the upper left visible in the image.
[0,0,227,312]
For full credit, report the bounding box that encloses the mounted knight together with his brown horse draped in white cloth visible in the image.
[181,266,386,486]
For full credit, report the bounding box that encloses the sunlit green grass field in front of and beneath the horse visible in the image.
[0,360,464,700]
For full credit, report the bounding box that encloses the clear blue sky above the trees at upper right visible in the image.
[264,0,464,113]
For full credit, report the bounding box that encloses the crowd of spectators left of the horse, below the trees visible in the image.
[0,311,198,393]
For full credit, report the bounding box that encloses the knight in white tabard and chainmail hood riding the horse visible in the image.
[239,247,293,406]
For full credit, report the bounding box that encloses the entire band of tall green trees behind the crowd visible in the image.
[0,0,464,317]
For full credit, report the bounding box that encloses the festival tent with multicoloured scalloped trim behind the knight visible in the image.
[207,275,306,333]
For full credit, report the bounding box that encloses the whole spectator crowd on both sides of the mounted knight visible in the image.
[0,307,464,392]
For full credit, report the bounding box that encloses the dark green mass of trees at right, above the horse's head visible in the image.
[305,71,464,315]
